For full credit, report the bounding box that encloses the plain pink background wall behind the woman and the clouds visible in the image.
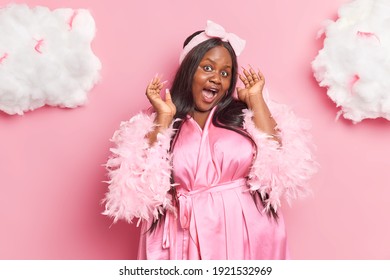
[0,0,390,259]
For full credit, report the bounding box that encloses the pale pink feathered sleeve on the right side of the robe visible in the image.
[244,98,318,211]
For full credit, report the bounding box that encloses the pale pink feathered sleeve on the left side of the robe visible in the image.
[103,113,173,223]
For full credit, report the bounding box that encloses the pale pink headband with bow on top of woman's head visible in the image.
[179,20,246,63]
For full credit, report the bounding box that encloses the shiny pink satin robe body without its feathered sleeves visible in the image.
[138,106,288,260]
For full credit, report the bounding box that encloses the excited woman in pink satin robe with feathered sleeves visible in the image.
[105,21,315,259]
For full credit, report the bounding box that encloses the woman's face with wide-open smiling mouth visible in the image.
[192,46,232,112]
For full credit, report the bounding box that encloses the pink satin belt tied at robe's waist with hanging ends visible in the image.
[163,178,246,248]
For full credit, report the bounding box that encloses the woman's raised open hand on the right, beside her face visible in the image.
[237,67,265,108]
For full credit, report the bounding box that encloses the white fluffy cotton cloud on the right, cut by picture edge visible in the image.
[312,0,390,123]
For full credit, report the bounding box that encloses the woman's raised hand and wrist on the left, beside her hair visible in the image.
[146,76,176,127]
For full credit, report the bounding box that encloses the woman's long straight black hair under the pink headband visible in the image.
[150,31,277,231]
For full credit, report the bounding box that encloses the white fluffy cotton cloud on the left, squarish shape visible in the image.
[0,4,101,115]
